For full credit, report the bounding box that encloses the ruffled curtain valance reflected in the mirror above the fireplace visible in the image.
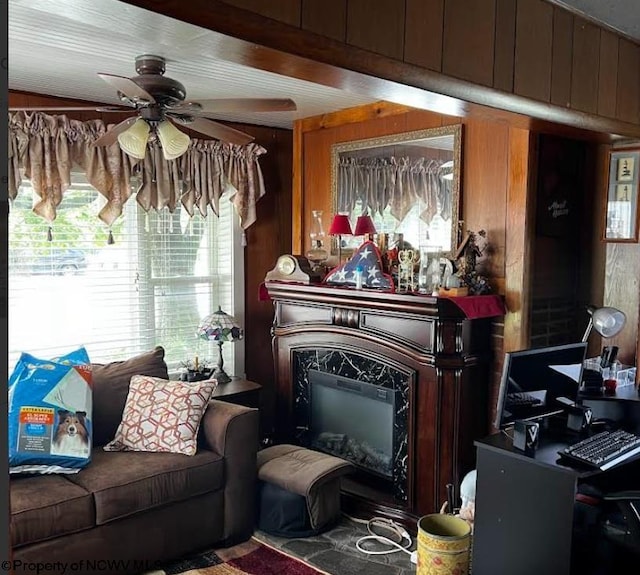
[338,156,452,223]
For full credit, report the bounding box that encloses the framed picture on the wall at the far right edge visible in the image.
[604,148,640,242]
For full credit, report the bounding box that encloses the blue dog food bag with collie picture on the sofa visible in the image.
[8,347,92,473]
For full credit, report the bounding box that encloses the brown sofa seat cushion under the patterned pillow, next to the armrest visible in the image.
[67,449,224,525]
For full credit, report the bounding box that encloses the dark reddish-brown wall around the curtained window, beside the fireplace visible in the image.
[9,92,293,431]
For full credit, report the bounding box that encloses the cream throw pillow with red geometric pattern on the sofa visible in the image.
[104,375,217,455]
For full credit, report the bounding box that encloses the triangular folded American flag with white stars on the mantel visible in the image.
[323,241,395,292]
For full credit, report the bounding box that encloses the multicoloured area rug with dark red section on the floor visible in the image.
[145,538,329,575]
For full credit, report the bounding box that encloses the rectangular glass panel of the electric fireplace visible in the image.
[309,370,395,479]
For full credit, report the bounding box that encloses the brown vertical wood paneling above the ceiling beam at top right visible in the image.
[215,0,640,131]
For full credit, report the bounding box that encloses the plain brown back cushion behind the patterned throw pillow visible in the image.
[91,346,169,446]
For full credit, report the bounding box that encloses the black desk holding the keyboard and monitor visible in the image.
[472,429,640,575]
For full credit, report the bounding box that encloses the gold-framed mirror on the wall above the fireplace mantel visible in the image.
[331,124,462,258]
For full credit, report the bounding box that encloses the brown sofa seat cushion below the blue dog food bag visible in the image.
[9,475,95,547]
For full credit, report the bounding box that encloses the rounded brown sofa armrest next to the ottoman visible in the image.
[201,400,259,544]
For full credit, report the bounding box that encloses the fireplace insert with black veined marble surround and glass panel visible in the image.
[292,346,413,504]
